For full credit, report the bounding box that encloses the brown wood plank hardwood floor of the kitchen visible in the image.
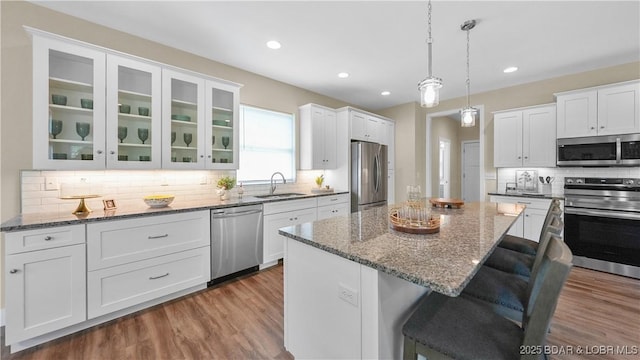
[1,266,640,360]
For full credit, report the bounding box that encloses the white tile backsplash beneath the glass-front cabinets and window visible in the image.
[20,170,322,214]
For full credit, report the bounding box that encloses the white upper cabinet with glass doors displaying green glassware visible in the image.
[33,34,240,170]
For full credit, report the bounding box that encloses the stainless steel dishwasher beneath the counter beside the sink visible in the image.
[211,205,262,282]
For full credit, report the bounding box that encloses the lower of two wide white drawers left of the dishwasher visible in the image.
[87,246,210,319]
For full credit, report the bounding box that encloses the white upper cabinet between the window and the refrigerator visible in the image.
[299,104,337,170]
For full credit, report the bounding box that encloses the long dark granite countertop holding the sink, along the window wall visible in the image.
[0,191,349,232]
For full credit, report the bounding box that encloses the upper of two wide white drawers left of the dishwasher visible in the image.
[87,211,211,271]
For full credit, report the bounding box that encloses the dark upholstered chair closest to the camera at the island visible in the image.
[402,236,572,360]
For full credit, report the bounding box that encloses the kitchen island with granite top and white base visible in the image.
[280,203,519,359]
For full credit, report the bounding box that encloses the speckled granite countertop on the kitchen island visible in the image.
[280,202,521,296]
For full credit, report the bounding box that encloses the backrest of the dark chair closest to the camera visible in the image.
[522,235,573,352]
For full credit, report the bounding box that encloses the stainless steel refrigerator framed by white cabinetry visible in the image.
[351,141,387,212]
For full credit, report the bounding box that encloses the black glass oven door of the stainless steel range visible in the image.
[564,207,640,266]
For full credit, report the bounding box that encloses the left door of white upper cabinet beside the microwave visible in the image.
[493,111,522,167]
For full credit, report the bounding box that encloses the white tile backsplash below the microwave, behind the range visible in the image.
[495,167,640,196]
